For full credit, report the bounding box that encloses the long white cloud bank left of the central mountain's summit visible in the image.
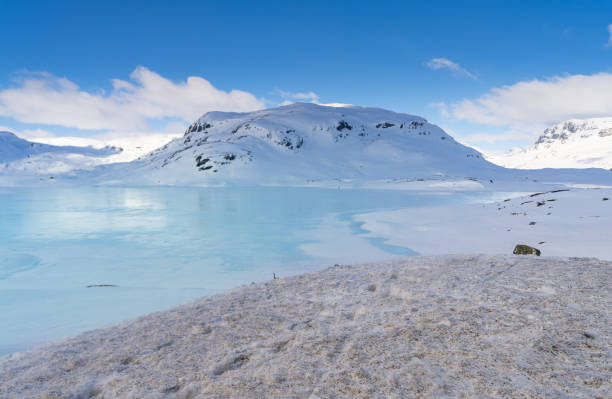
[0,67,264,130]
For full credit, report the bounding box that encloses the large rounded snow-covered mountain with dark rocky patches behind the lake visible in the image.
[95,103,502,185]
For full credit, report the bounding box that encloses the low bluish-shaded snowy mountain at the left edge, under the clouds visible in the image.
[0,132,122,175]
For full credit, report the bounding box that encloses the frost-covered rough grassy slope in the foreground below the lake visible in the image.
[0,255,612,399]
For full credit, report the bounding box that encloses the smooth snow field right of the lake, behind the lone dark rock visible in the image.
[355,188,612,260]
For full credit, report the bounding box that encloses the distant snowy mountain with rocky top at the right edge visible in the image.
[487,118,612,169]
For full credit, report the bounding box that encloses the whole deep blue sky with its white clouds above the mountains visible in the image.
[0,0,612,150]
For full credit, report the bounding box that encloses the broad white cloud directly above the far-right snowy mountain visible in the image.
[450,73,612,131]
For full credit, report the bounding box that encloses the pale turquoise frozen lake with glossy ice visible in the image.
[0,187,491,355]
